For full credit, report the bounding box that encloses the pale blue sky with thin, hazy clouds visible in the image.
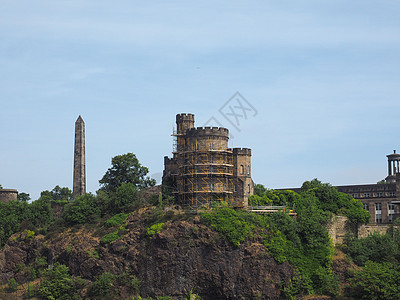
[0,0,400,200]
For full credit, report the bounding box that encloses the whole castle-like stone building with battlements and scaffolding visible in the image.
[163,114,254,208]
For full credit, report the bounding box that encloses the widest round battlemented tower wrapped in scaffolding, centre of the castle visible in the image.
[177,127,234,208]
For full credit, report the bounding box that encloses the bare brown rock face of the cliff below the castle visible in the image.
[0,211,295,299]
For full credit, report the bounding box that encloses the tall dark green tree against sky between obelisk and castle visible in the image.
[99,153,156,192]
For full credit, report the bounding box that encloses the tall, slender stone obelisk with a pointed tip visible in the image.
[72,116,86,199]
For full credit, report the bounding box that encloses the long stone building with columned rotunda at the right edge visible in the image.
[284,150,400,224]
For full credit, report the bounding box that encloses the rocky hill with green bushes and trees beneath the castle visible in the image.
[0,154,384,299]
